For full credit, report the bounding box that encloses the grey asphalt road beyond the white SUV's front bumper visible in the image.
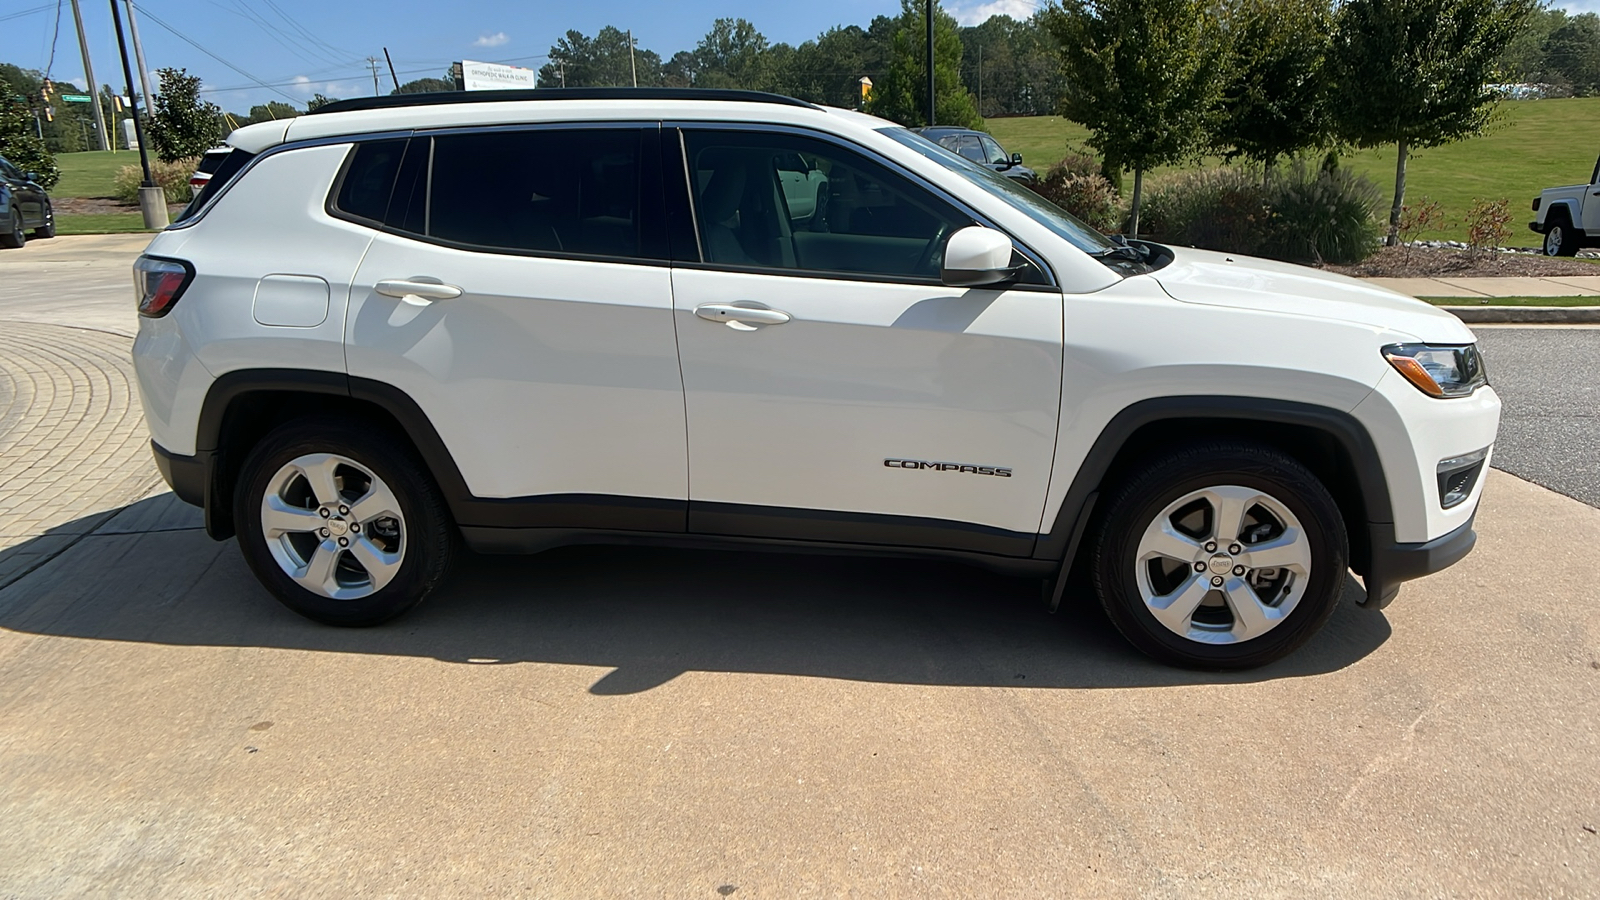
[1475,327,1600,508]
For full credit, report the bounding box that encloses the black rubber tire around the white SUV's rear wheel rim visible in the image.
[234,416,459,628]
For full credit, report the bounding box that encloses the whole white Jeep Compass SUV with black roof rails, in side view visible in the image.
[134,90,1499,668]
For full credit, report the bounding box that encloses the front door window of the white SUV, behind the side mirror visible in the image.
[685,131,973,277]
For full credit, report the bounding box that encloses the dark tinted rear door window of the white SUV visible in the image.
[426,128,646,258]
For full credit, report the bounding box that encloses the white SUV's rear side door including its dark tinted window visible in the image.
[346,125,686,522]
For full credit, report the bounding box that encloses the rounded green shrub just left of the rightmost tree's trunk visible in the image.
[1261,163,1382,266]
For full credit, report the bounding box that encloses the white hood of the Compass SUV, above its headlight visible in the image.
[1149,247,1477,344]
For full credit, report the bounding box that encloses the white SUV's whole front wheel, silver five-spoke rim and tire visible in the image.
[1093,444,1347,669]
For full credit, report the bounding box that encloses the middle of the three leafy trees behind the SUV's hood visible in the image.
[1213,0,1333,168]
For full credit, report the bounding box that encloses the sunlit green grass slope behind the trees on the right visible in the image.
[987,98,1600,247]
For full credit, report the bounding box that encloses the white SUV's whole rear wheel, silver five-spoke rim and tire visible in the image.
[234,418,456,626]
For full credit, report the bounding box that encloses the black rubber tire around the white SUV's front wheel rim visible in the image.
[1091,442,1347,669]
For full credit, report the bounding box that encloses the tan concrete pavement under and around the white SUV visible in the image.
[0,235,1600,898]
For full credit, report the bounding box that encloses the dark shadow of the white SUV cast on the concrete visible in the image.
[0,495,1390,695]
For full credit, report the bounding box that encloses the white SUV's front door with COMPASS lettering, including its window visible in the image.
[672,130,1062,556]
